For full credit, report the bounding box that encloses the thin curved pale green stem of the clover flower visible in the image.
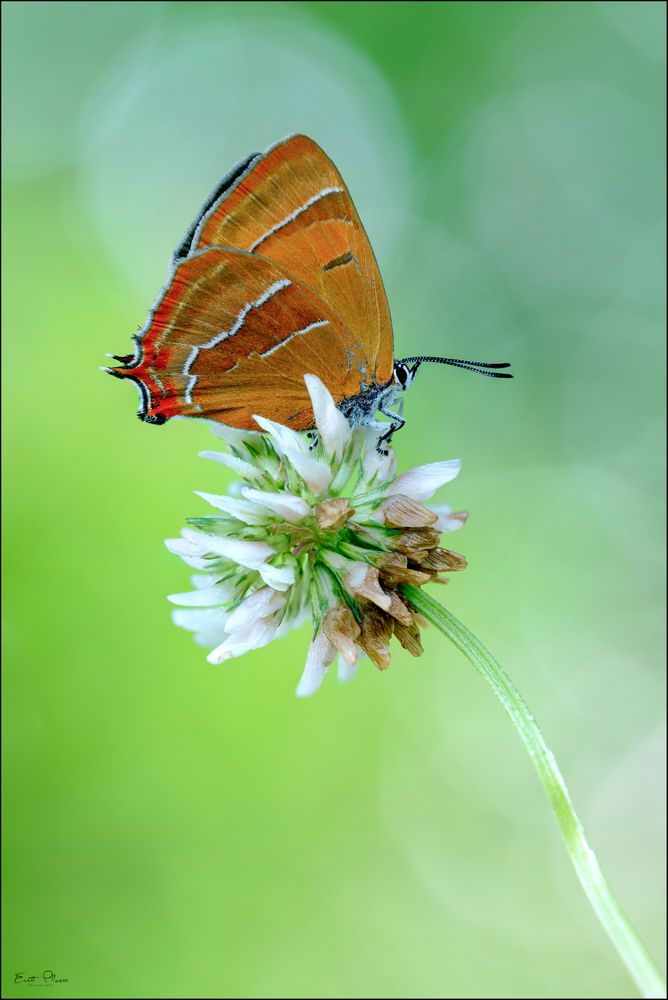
[402,585,666,998]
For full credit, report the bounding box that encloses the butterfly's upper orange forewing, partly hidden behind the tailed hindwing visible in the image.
[184,135,394,385]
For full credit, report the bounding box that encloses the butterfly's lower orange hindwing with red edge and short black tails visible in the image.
[110,247,363,429]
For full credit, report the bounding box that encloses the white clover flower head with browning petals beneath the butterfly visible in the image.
[165,375,466,696]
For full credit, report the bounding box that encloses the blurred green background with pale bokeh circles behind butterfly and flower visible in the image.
[3,0,665,997]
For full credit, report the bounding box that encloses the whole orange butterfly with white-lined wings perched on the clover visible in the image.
[105,135,512,446]
